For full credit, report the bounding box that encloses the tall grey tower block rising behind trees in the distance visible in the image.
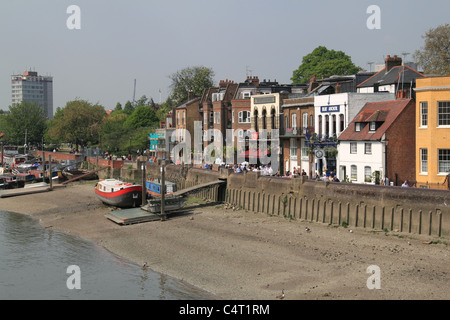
[11,71,53,119]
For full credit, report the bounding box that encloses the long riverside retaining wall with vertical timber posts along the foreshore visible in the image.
[99,163,450,237]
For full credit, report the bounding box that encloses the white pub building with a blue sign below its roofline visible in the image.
[314,92,395,175]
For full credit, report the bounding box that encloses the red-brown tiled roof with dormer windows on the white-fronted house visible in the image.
[338,99,415,141]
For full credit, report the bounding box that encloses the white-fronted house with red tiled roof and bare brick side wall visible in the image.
[337,99,416,186]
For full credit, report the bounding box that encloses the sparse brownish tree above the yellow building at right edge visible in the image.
[414,24,450,75]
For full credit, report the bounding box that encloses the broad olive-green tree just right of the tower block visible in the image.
[48,100,106,151]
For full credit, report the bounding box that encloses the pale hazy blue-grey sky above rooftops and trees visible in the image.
[0,0,450,114]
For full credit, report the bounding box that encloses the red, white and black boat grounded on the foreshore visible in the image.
[95,179,142,208]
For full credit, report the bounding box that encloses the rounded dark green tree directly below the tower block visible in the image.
[0,101,47,145]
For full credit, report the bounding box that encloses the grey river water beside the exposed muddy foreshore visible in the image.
[0,211,212,300]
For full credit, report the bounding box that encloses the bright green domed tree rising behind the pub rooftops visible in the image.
[291,46,361,84]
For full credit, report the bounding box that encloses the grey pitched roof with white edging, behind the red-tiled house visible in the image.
[358,65,426,88]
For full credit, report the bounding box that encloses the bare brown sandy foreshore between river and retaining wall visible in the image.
[0,183,450,300]
